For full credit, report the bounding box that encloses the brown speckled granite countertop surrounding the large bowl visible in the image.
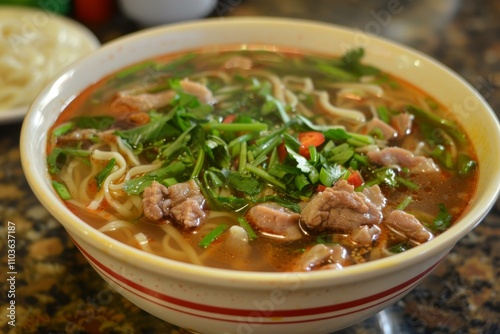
[0,0,500,334]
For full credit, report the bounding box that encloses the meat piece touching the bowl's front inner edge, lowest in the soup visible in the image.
[293,244,347,271]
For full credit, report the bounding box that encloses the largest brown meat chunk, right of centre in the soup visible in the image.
[301,180,385,232]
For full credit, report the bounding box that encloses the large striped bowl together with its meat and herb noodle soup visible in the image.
[21,18,500,333]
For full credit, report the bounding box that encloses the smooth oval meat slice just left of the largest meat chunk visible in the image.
[245,202,302,241]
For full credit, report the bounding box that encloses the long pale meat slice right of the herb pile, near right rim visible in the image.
[366,147,439,173]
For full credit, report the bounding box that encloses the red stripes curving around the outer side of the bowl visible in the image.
[73,240,443,324]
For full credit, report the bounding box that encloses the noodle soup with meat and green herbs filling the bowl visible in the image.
[47,47,477,271]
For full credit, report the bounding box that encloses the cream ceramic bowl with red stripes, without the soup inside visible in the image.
[21,18,500,333]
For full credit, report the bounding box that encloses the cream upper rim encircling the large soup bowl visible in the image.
[20,17,500,289]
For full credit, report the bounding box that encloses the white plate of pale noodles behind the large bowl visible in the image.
[0,5,100,122]
